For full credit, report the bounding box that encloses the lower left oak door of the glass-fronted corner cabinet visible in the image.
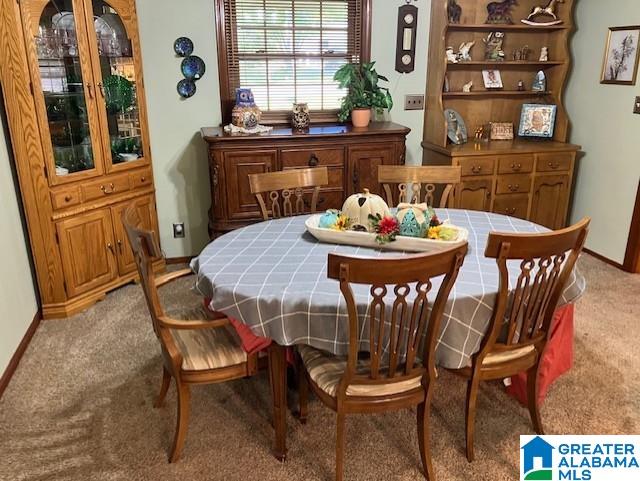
[56,209,118,297]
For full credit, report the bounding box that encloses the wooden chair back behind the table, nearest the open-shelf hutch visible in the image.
[378,165,462,208]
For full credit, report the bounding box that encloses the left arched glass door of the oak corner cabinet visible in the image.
[21,0,102,184]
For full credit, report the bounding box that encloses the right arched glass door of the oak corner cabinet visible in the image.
[85,0,148,171]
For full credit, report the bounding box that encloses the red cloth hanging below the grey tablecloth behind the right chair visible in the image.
[507,304,574,406]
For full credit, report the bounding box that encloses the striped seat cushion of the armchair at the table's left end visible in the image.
[170,307,247,371]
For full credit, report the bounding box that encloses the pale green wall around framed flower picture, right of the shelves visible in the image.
[565,0,640,262]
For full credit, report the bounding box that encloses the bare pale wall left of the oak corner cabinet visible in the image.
[0,114,38,375]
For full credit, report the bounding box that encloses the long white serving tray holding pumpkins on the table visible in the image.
[305,214,469,252]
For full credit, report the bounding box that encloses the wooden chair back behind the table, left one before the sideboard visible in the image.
[249,167,329,220]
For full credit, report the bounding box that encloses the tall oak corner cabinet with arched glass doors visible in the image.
[0,0,160,318]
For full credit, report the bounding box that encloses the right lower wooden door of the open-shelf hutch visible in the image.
[530,175,569,229]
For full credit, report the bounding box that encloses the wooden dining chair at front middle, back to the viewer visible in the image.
[298,244,467,481]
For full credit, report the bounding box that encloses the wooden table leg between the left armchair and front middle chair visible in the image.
[269,342,287,461]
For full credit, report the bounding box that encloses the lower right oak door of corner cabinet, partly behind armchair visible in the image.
[111,195,159,276]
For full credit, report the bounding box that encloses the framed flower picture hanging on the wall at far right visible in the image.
[600,25,640,85]
